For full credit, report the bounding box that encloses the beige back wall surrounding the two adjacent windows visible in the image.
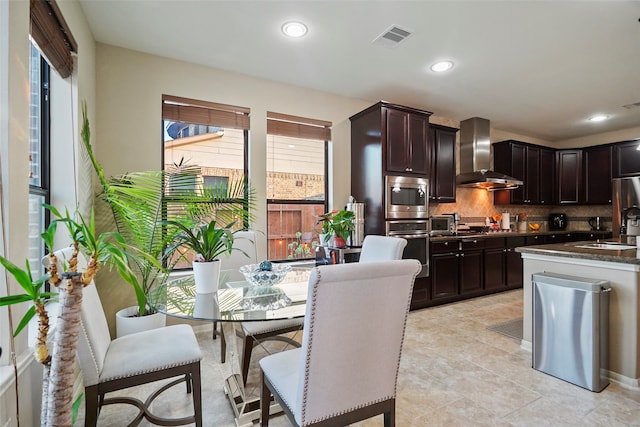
[93,44,371,332]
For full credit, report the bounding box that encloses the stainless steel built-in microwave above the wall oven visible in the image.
[384,175,429,219]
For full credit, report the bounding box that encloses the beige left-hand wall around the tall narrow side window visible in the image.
[0,1,95,427]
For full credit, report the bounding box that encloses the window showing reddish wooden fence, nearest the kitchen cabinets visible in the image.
[267,112,331,260]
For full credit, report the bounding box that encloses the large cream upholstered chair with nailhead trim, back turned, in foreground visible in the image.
[260,259,421,427]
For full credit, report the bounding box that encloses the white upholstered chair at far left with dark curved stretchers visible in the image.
[42,248,202,426]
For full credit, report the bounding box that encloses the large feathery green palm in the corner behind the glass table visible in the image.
[81,108,255,335]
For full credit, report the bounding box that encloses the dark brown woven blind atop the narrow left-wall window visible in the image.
[29,0,78,79]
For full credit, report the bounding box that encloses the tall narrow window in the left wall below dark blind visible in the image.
[28,44,50,287]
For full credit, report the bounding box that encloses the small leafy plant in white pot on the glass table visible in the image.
[159,220,239,294]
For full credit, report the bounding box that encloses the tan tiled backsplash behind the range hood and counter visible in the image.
[429,187,612,230]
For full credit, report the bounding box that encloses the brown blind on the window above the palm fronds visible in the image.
[162,95,251,130]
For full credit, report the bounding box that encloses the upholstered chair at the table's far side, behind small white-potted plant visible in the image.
[220,230,303,385]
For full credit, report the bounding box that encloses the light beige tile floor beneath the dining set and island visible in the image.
[76,290,640,427]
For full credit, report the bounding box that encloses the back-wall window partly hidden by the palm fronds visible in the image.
[162,95,249,268]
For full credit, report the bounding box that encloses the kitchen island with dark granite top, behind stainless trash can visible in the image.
[516,242,640,389]
